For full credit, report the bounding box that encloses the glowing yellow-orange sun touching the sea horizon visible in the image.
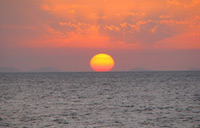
[90,53,115,72]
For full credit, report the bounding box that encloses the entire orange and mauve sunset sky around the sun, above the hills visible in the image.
[0,0,200,71]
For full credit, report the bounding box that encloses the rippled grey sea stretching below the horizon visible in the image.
[0,72,200,128]
